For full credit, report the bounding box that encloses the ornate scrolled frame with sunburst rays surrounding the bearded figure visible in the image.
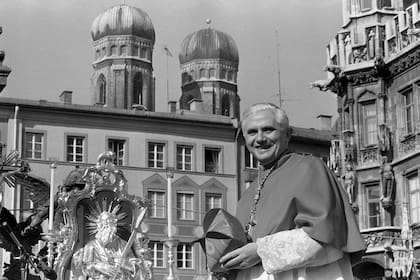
[54,151,152,280]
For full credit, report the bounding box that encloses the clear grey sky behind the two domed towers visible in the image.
[0,0,342,128]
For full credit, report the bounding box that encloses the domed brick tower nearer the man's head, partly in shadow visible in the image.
[179,20,240,118]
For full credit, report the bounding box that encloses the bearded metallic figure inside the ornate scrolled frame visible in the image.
[72,211,143,280]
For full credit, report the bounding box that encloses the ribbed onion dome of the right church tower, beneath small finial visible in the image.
[179,28,239,64]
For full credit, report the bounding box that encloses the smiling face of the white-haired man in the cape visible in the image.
[243,110,290,166]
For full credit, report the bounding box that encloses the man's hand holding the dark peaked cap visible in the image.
[219,242,261,269]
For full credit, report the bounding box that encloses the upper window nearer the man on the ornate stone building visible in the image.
[361,102,378,146]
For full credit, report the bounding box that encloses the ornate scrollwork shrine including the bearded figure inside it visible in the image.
[54,152,152,280]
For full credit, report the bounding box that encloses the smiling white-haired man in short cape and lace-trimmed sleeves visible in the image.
[220,103,365,280]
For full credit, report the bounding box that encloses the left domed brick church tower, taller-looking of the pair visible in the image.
[91,4,155,111]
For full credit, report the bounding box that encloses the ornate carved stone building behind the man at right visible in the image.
[322,0,420,279]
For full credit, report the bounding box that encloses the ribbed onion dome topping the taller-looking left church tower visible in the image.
[91,4,155,44]
